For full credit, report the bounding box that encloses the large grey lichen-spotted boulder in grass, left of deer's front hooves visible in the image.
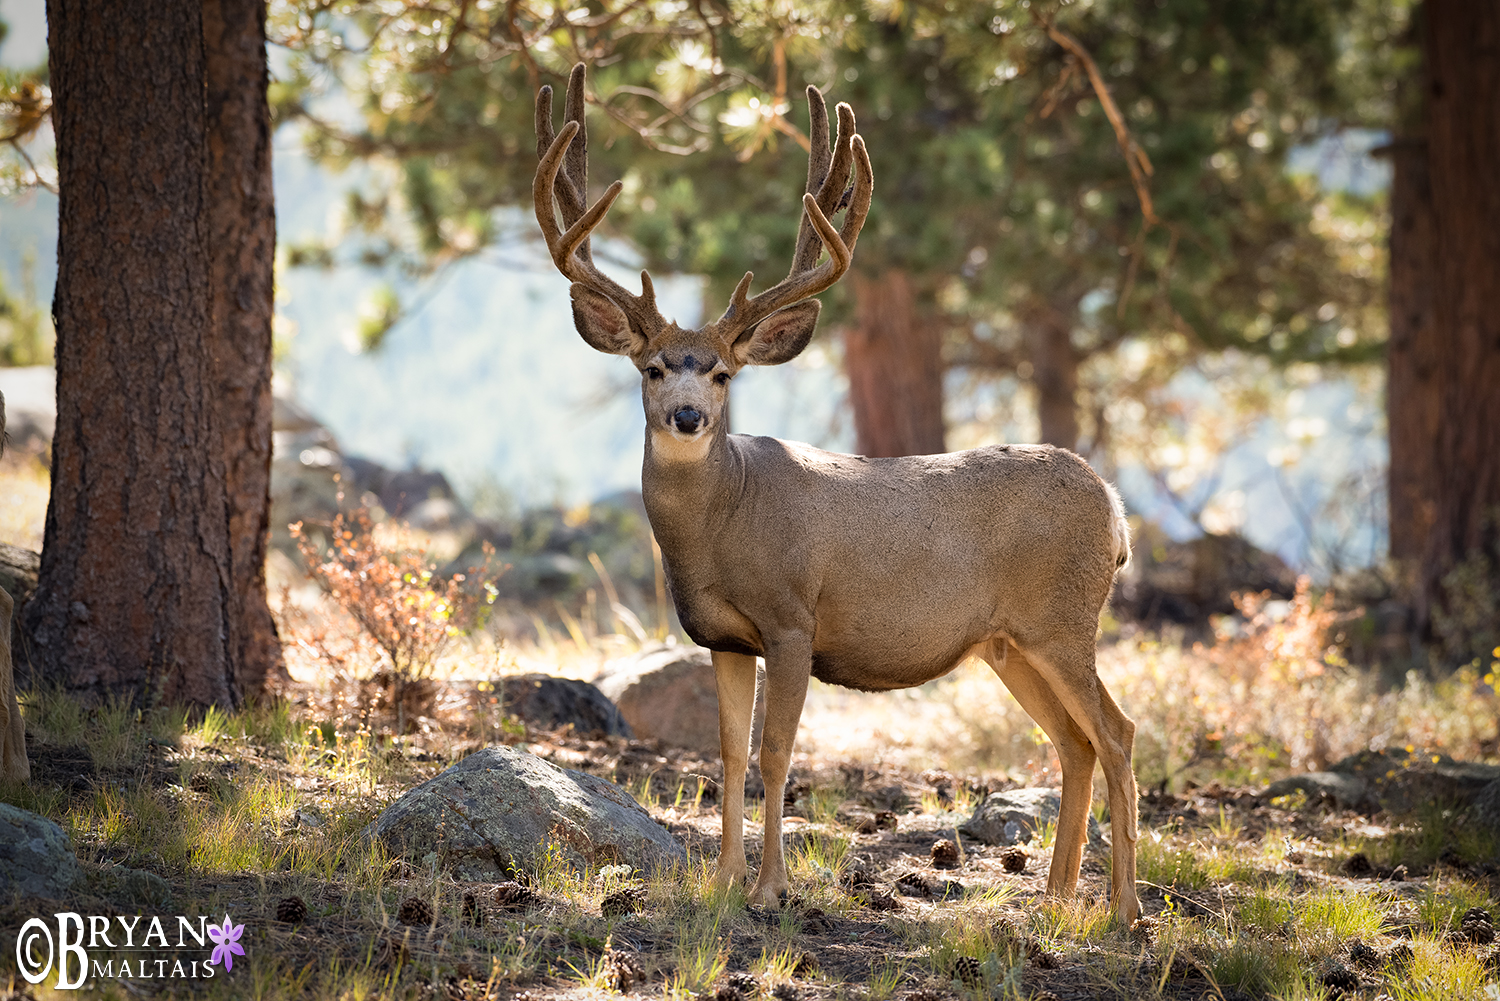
[365,746,687,882]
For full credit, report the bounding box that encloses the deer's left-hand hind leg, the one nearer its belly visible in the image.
[984,639,1095,896]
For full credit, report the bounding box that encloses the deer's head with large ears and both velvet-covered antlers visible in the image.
[533,63,875,453]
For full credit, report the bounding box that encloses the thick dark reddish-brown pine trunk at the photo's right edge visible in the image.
[1424,0,1500,627]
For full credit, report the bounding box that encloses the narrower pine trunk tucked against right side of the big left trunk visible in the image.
[203,0,287,695]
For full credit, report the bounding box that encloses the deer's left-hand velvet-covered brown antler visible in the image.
[531,63,666,336]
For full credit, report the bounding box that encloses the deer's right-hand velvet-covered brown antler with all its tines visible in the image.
[719,87,875,341]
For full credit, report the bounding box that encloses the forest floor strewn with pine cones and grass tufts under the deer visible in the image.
[0,657,1500,1001]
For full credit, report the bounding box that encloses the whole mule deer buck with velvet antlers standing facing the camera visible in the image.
[533,65,1140,923]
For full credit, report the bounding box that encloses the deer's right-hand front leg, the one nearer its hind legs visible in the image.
[749,636,813,908]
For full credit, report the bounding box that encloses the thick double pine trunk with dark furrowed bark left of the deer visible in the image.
[27,0,279,705]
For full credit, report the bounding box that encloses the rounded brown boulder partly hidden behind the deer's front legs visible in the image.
[596,645,765,756]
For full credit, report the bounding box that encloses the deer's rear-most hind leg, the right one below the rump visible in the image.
[1026,632,1140,924]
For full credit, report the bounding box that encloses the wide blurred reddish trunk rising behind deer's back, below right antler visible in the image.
[845,269,944,456]
